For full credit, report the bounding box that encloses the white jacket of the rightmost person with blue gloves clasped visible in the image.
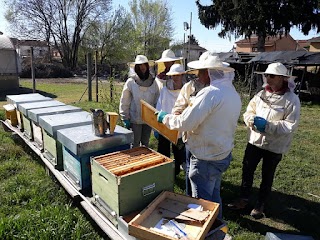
[243,90,300,153]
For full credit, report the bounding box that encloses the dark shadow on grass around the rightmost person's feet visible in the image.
[221,182,320,240]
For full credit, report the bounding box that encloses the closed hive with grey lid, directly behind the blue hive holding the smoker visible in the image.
[39,111,92,170]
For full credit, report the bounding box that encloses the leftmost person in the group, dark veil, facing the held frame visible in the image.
[119,55,159,147]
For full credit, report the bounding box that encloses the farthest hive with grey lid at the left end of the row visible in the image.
[7,93,52,131]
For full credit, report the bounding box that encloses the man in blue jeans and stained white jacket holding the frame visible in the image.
[157,54,241,218]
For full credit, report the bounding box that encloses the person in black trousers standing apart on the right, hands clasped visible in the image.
[228,62,300,219]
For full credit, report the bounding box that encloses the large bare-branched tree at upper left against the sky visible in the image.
[6,0,111,69]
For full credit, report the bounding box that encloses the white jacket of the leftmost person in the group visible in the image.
[119,74,159,124]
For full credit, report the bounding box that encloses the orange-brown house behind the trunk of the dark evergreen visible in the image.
[236,34,304,53]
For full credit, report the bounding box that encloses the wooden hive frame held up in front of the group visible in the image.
[140,100,179,144]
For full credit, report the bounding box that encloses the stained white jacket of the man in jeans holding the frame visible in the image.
[163,80,241,160]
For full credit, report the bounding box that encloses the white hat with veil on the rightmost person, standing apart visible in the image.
[255,62,296,92]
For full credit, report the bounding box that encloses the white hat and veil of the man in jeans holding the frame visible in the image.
[187,51,235,84]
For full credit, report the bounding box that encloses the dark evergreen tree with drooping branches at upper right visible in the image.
[196,0,320,52]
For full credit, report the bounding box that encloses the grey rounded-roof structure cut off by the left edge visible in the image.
[0,32,21,92]
